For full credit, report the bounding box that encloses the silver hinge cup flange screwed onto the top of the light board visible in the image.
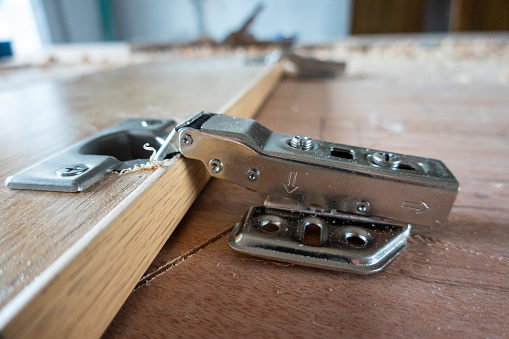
[5,119,176,192]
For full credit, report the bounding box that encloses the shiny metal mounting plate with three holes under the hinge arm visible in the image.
[229,206,410,274]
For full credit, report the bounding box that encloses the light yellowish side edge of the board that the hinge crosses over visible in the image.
[0,65,283,338]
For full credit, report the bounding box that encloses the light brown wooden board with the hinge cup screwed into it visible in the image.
[0,58,281,337]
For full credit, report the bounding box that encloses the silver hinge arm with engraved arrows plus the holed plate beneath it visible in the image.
[170,113,458,273]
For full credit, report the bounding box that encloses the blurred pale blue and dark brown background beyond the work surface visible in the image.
[0,0,509,56]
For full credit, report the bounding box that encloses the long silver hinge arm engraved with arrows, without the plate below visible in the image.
[174,114,458,226]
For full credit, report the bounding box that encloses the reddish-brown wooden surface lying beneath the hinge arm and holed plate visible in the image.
[104,51,509,338]
